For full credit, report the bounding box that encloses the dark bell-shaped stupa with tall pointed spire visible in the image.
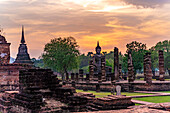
[14,26,33,64]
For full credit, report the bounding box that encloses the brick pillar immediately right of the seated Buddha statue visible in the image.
[101,56,106,81]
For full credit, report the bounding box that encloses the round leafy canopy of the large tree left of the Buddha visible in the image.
[42,37,79,76]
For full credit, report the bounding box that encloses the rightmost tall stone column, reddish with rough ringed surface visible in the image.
[159,50,165,81]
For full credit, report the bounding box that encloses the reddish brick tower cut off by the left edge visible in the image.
[0,35,11,64]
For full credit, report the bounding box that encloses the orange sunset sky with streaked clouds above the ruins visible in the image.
[0,0,170,58]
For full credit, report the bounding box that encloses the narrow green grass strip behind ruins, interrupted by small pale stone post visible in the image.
[76,89,152,98]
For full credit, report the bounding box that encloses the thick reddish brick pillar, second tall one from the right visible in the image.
[145,52,152,85]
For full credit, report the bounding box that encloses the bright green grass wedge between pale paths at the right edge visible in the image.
[134,96,170,103]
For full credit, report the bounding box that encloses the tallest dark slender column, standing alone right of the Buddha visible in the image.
[114,47,119,81]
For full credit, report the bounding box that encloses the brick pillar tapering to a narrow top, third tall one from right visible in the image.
[128,51,135,82]
